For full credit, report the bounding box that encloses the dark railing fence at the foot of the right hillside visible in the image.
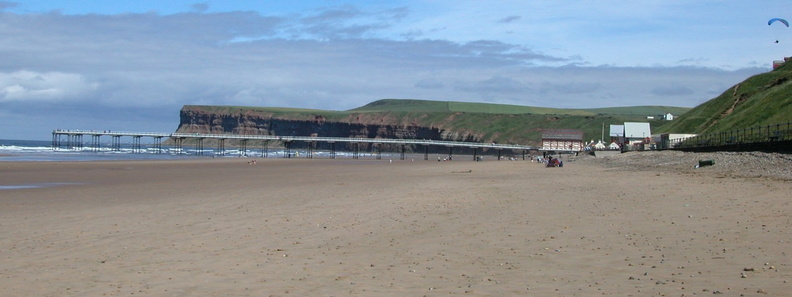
[665,122,792,153]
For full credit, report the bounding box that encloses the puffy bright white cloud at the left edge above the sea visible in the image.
[0,70,99,102]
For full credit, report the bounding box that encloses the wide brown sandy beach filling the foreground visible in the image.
[0,158,792,296]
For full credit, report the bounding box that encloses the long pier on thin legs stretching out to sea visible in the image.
[52,129,538,160]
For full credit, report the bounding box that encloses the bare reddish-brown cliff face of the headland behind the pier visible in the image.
[177,107,478,141]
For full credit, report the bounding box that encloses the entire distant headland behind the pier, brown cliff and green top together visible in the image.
[178,99,687,145]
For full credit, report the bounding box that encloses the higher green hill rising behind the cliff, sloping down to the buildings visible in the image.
[349,99,676,144]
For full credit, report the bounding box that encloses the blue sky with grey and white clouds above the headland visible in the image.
[0,0,792,140]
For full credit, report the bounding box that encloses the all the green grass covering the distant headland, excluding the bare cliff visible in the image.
[185,99,676,144]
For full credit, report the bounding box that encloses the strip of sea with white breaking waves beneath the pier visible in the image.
[0,139,386,162]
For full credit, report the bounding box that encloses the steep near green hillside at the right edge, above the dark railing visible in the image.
[653,63,792,134]
